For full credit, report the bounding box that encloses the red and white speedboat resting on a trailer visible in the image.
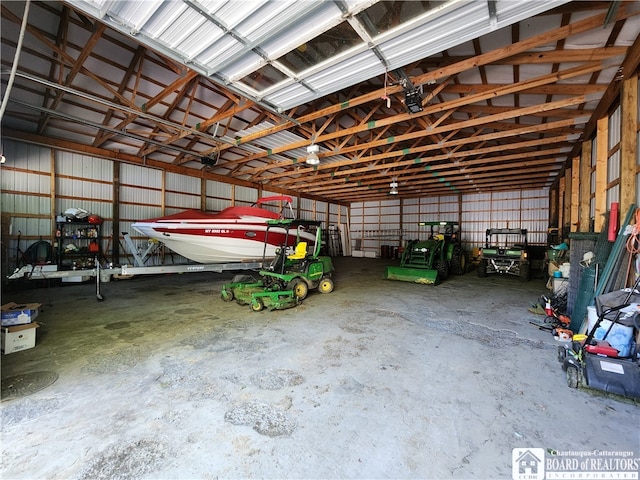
[131,195,315,263]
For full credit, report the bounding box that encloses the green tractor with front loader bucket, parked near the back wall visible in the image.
[384,221,467,285]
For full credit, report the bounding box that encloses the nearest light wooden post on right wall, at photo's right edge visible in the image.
[620,75,639,213]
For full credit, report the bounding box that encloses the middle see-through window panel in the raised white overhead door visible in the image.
[278,22,363,73]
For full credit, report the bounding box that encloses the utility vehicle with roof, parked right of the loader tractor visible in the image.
[478,228,530,282]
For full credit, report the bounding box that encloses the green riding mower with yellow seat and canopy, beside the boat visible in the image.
[221,219,334,312]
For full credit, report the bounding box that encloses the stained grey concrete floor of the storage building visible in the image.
[0,258,640,479]
